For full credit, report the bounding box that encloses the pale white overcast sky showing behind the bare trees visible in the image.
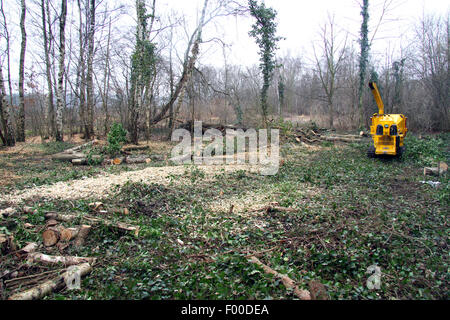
[2,0,450,86]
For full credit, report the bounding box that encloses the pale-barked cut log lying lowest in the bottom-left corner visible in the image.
[8,263,92,300]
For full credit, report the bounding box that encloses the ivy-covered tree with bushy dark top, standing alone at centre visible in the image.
[248,0,282,127]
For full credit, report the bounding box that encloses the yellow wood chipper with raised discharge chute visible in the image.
[367,82,408,158]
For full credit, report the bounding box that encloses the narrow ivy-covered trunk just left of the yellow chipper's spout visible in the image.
[358,0,370,129]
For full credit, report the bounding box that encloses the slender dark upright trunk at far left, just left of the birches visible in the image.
[17,0,27,142]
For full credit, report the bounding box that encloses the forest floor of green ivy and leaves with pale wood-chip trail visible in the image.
[0,134,450,299]
